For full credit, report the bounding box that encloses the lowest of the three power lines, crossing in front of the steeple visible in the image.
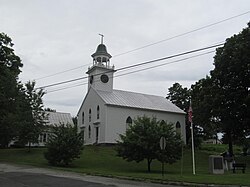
[46,50,215,93]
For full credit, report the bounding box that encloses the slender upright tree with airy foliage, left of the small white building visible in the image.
[18,81,46,148]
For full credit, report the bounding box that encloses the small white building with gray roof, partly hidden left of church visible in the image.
[36,111,74,146]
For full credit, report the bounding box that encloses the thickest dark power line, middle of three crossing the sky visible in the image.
[37,43,224,89]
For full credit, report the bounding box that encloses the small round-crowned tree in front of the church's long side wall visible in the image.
[116,116,182,172]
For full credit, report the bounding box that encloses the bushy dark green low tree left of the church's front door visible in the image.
[44,124,84,166]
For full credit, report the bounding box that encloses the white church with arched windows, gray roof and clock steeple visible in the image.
[77,43,186,145]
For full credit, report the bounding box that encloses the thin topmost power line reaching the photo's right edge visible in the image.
[32,11,250,80]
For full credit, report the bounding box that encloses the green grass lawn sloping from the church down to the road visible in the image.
[0,145,250,185]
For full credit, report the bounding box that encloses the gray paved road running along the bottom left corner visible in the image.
[0,163,181,187]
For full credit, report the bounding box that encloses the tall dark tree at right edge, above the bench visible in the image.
[210,22,250,154]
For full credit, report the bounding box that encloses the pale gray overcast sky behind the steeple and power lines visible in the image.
[0,0,250,116]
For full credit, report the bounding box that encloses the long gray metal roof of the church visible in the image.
[96,90,185,114]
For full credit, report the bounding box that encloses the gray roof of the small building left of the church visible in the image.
[46,111,73,125]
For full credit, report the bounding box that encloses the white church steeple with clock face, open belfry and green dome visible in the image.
[87,38,115,92]
